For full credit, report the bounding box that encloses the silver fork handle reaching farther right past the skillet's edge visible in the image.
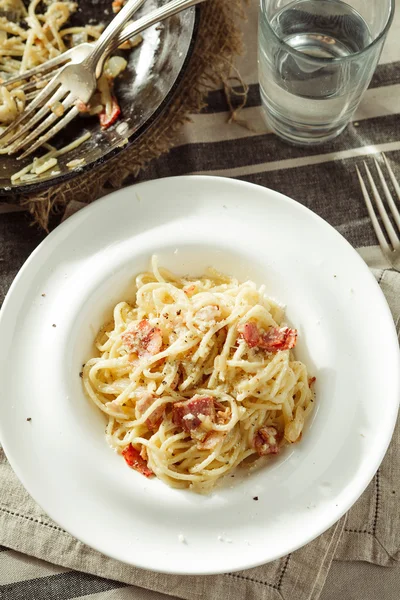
[95,0,204,78]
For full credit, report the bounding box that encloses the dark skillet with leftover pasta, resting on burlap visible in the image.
[0,0,199,196]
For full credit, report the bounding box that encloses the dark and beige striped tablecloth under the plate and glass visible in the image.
[0,0,400,600]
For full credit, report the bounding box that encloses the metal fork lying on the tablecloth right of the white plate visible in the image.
[356,154,400,271]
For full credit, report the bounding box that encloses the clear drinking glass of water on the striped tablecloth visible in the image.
[258,0,395,145]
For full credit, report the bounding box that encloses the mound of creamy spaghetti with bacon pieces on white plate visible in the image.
[81,257,314,493]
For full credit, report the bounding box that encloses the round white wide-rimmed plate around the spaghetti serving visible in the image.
[0,177,399,574]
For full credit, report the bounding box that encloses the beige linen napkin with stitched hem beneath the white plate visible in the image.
[0,203,400,600]
